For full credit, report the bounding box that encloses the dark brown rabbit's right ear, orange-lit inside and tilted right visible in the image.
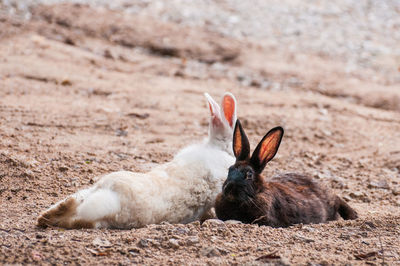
[250,127,284,173]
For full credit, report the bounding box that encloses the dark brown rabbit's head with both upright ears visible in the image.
[222,120,284,202]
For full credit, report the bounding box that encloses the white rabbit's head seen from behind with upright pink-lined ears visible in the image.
[204,92,236,155]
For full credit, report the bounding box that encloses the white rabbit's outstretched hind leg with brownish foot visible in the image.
[37,188,120,229]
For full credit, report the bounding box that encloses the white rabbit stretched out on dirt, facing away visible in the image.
[38,93,236,229]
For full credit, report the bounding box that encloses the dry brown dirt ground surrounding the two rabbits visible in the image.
[0,2,400,265]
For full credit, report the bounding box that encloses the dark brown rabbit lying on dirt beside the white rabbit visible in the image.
[215,120,357,227]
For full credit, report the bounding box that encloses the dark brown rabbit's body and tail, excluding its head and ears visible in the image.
[215,173,357,227]
